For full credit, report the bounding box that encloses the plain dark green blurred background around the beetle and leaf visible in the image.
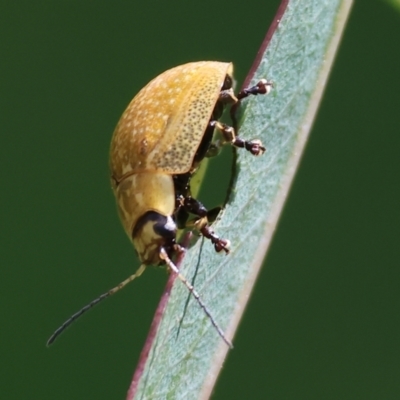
[0,0,400,400]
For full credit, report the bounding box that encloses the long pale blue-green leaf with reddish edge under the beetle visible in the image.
[128,0,351,400]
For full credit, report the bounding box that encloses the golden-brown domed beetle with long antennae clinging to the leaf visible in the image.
[48,61,273,347]
